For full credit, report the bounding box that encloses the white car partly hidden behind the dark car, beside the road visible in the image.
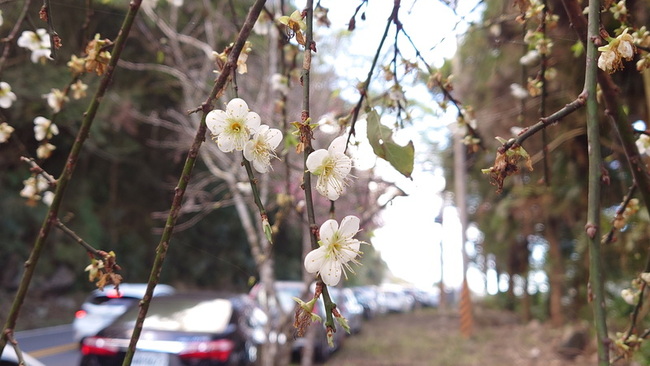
[72,283,174,344]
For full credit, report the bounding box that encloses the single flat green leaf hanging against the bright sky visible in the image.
[367,109,415,178]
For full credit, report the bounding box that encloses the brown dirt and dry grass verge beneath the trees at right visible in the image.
[326,309,618,366]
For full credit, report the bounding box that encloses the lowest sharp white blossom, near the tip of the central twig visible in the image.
[304,215,361,286]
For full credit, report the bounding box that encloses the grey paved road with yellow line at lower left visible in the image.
[15,324,81,366]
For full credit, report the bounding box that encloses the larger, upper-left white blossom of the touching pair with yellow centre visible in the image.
[205,98,260,152]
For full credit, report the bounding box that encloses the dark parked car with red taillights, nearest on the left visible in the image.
[81,293,267,366]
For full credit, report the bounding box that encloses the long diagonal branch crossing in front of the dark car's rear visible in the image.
[123,0,265,366]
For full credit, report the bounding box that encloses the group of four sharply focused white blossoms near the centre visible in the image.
[205,98,360,286]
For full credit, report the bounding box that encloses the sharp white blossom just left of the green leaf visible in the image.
[306,136,352,201]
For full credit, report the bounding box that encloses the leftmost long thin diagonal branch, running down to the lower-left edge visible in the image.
[0,0,142,349]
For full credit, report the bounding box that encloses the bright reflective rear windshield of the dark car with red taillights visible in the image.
[119,298,233,333]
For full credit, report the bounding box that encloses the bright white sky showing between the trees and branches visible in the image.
[296,0,483,291]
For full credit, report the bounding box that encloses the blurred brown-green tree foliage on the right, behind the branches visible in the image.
[444,0,648,328]
